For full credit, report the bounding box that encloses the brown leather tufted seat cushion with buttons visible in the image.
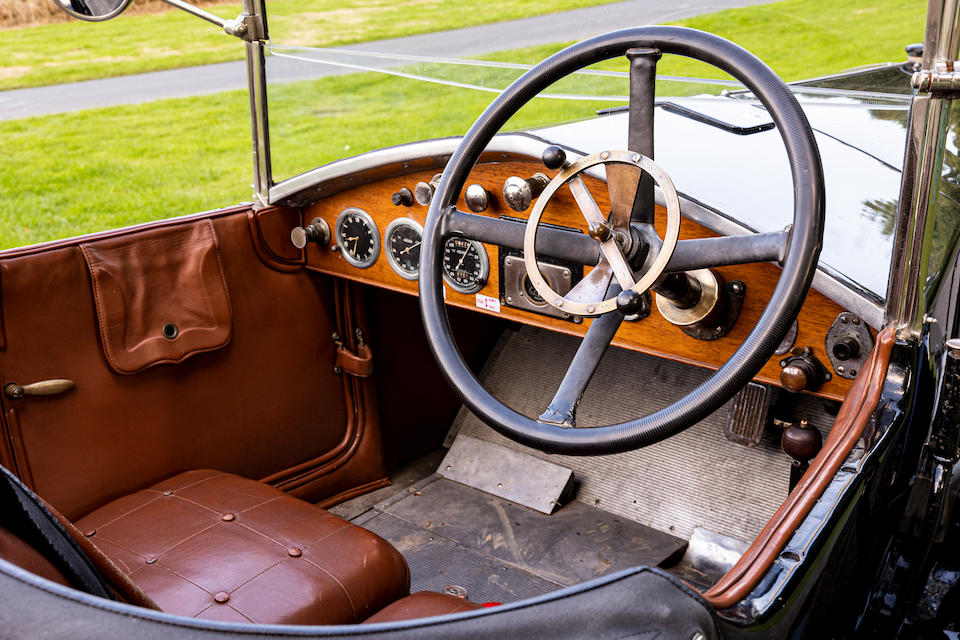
[76,470,410,624]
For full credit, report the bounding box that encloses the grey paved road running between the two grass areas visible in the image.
[0,0,770,120]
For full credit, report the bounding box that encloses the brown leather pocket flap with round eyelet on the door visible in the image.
[80,220,232,374]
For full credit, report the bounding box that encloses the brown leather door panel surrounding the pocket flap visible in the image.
[0,209,383,518]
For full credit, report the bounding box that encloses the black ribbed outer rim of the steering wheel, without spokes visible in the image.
[420,26,824,455]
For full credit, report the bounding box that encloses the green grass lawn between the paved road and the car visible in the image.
[0,0,924,247]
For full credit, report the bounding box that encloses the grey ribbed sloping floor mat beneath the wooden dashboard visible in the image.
[455,327,833,541]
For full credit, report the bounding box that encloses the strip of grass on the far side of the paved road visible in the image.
[0,0,615,90]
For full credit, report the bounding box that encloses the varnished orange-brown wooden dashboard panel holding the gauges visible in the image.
[302,160,864,400]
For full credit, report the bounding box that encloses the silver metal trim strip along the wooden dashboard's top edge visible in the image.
[269,133,884,329]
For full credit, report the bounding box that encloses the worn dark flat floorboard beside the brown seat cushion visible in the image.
[354,476,686,602]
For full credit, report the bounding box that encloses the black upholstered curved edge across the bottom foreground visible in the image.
[0,560,721,640]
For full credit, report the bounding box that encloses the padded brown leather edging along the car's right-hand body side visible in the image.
[703,328,896,609]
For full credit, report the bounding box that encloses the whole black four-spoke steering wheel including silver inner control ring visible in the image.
[420,26,824,455]
